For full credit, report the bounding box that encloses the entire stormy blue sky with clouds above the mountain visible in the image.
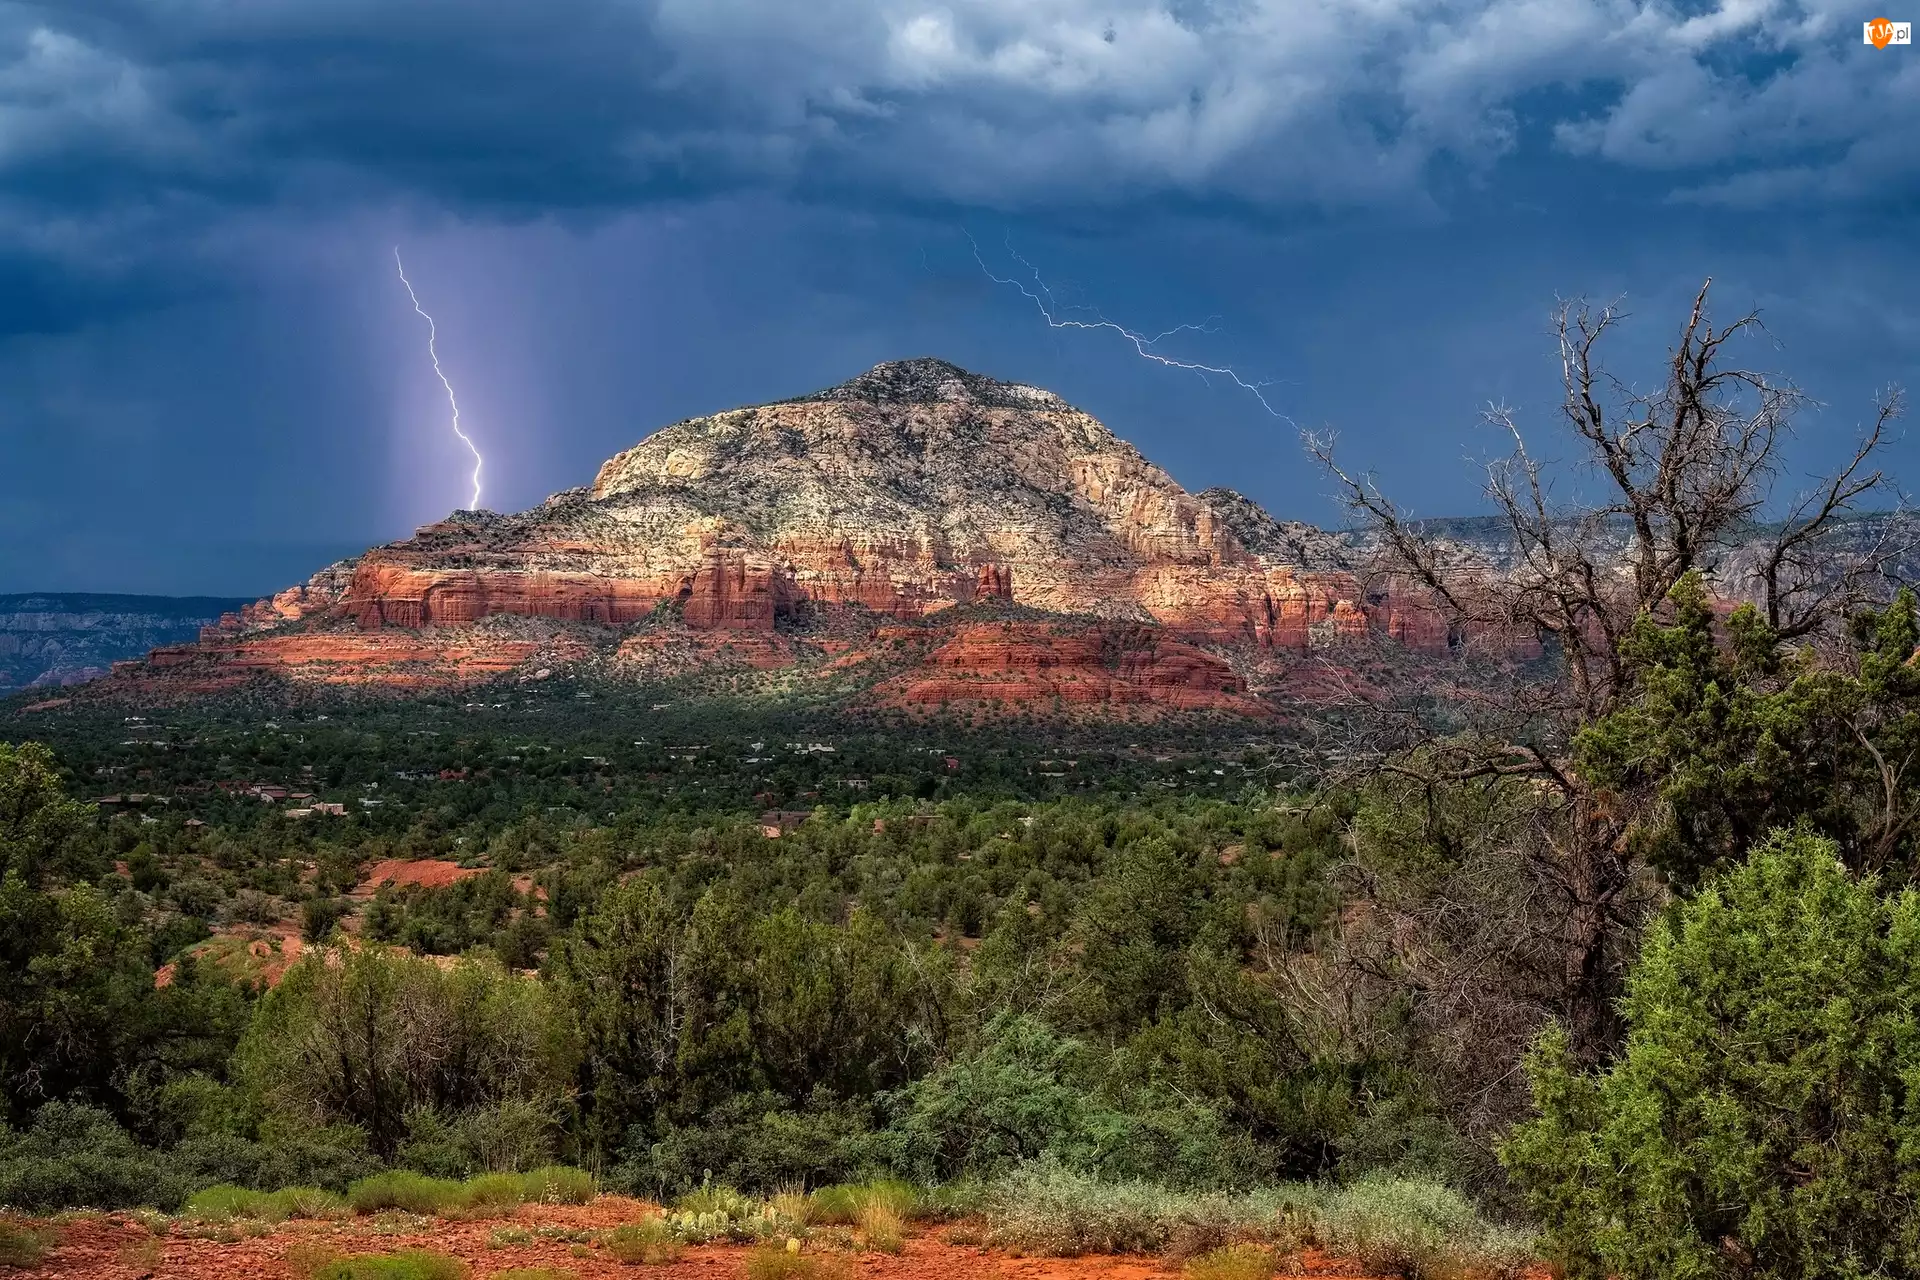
[0,0,1920,595]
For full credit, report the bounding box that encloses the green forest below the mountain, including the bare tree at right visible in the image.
[0,285,1920,1280]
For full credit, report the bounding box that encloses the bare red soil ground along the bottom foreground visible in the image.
[10,1196,1428,1280]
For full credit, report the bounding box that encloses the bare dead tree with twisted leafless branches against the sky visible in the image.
[1308,280,1914,1057]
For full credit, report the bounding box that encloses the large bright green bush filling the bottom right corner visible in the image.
[1501,831,1920,1280]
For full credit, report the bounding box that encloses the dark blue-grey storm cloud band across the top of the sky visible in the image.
[0,0,1920,230]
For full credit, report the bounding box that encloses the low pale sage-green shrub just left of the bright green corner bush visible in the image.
[1313,1178,1532,1280]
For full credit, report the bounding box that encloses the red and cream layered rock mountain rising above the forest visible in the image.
[119,359,1448,706]
